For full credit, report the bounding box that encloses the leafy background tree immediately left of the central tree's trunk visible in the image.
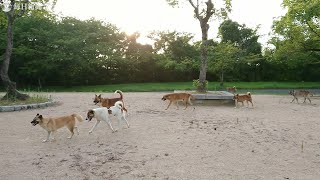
[149,31,199,81]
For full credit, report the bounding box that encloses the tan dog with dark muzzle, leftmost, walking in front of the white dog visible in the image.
[31,114,83,142]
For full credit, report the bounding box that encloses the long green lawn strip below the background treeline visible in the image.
[33,81,320,93]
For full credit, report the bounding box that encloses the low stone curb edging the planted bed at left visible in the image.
[0,101,57,112]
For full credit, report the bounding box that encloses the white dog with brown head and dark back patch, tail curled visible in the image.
[86,101,130,134]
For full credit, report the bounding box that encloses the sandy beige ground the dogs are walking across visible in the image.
[0,93,320,180]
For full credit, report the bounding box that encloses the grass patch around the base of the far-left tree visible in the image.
[0,94,51,106]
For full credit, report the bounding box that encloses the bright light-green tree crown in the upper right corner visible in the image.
[269,0,320,66]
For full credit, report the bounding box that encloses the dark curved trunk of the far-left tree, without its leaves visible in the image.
[0,10,29,100]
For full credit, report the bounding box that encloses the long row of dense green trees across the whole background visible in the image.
[0,1,320,88]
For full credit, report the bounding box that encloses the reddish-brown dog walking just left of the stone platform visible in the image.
[161,93,194,110]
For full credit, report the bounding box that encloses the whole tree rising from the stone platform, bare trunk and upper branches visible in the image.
[166,0,231,92]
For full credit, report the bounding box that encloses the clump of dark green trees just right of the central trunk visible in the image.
[215,20,266,81]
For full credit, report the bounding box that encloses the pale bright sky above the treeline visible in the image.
[55,0,285,46]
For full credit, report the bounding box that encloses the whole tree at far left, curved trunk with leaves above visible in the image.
[0,0,57,100]
